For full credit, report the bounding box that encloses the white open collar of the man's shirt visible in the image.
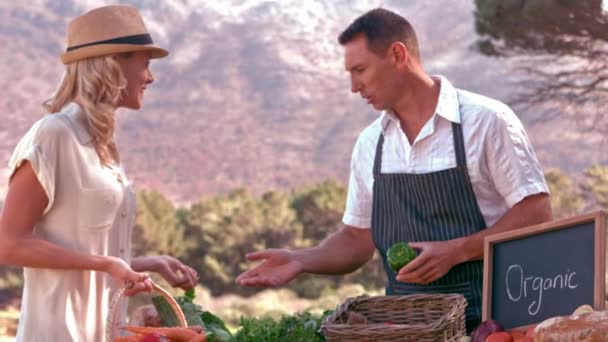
[381,76,460,131]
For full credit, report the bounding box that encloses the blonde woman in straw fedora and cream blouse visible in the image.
[0,6,198,342]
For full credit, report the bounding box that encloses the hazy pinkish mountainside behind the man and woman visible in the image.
[0,0,606,203]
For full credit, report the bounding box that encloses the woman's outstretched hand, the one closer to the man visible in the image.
[132,255,199,290]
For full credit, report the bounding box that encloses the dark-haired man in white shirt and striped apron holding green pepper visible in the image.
[236,9,552,331]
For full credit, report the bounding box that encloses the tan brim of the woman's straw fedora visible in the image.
[61,44,169,64]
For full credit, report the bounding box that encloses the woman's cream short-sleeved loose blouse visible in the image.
[9,103,135,342]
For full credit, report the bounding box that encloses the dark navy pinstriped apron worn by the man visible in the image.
[372,95,486,332]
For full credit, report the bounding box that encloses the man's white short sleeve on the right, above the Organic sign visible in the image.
[485,109,549,208]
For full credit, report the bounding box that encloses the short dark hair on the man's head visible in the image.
[338,8,420,60]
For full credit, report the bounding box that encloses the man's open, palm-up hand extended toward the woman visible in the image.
[236,249,302,287]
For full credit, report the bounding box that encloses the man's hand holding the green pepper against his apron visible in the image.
[396,240,462,285]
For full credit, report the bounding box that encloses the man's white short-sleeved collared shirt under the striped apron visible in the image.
[343,77,549,228]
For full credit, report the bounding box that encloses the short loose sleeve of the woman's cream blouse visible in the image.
[8,119,58,215]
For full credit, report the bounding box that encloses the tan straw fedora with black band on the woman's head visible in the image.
[61,5,169,64]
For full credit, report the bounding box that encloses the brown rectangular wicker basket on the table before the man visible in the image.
[321,294,467,342]
